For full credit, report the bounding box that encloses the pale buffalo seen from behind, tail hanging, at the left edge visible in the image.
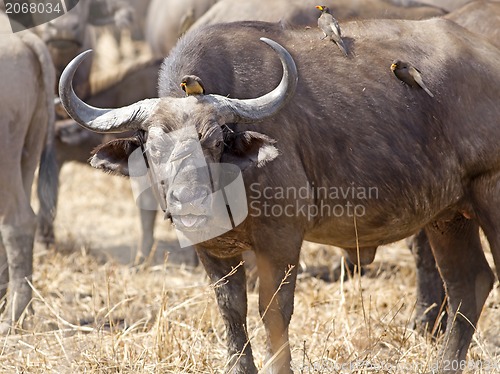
[0,13,57,334]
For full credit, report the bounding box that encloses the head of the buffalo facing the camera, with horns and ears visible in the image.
[59,38,297,231]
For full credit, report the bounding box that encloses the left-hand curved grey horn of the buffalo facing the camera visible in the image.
[59,50,159,133]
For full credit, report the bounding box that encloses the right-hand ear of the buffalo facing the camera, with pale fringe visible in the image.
[221,131,279,170]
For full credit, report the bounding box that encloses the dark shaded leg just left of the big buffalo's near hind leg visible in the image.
[409,230,446,334]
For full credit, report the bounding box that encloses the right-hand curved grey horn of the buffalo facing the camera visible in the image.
[212,38,298,122]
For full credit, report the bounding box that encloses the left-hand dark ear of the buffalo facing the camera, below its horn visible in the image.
[89,137,141,177]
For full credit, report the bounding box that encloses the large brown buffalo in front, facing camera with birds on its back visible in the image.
[60,19,500,373]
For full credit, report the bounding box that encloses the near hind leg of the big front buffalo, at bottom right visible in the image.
[425,214,494,373]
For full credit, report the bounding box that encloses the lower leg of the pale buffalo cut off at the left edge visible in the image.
[0,220,35,334]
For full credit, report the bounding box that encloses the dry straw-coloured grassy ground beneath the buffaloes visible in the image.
[0,160,500,373]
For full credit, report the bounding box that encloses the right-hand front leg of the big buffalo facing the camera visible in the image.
[256,231,302,374]
